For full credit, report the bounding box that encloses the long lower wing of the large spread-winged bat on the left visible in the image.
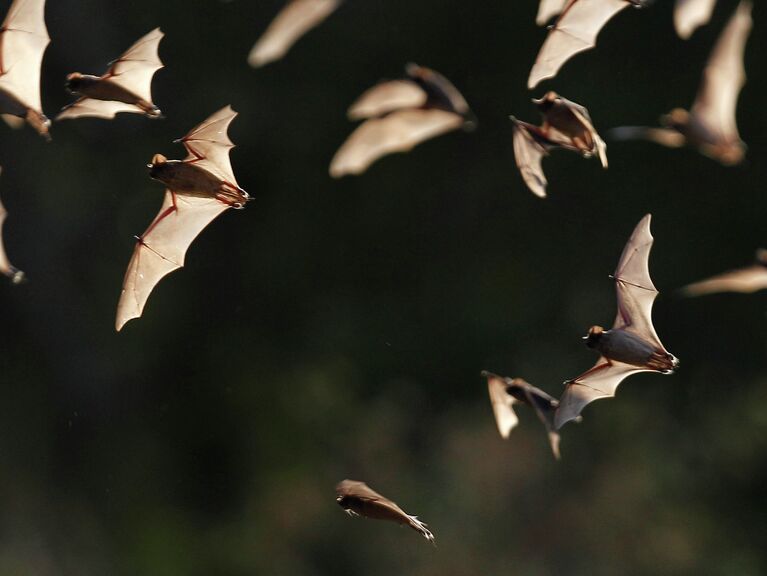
[115,190,229,332]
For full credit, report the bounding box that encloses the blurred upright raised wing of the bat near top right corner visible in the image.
[692,0,752,142]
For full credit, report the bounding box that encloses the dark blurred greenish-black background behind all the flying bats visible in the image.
[0,0,767,576]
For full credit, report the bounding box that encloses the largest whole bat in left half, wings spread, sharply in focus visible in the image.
[115,106,250,332]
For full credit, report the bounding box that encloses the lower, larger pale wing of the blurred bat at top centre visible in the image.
[330,108,464,178]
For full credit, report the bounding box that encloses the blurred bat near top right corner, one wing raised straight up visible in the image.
[610,0,752,166]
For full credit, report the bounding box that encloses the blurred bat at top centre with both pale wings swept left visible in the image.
[329,64,475,178]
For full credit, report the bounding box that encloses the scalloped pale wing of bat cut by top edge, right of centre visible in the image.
[527,0,647,90]
